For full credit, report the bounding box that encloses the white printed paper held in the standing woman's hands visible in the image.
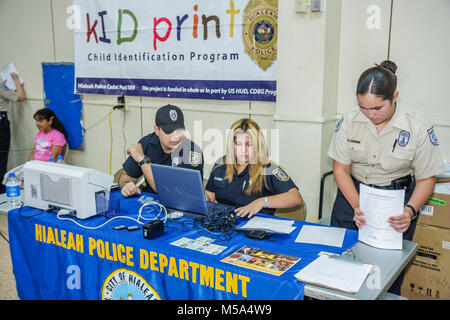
[358,184,405,250]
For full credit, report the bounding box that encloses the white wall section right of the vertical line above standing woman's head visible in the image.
[391,0,450,161]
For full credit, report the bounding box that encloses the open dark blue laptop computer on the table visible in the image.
[151,163,236,218]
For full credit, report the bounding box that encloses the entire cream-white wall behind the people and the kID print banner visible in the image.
[0,0,450,221]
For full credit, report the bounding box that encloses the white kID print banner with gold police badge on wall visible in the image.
[74,0,278,101]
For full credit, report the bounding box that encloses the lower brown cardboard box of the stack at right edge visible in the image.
[401,224,450,300]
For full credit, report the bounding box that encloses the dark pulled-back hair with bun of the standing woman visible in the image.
[356,60,397,101]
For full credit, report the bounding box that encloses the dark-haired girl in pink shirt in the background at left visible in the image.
[27,108,67,161]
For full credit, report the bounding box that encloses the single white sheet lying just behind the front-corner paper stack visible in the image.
[295,225,345,247]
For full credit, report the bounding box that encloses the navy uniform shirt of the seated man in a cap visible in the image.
[123,132,203,193]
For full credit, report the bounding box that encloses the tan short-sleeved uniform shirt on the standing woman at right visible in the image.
[328,105,445,186]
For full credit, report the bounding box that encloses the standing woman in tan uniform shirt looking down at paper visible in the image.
[328,60,444,240]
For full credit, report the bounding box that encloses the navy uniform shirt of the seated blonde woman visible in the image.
[206,159,298,215]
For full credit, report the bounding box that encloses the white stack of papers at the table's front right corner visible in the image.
[295,255,373,294]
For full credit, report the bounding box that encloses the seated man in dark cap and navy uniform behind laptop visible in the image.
[119,104,203,197]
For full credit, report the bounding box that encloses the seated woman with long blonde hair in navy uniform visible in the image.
[205,119,302,217]
